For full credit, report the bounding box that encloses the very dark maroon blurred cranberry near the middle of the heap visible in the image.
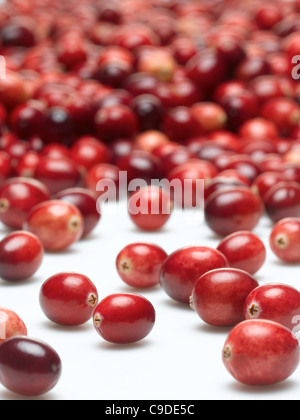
[130,94,164,131]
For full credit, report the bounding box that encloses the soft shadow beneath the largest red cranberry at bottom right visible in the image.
[227,379,299,395]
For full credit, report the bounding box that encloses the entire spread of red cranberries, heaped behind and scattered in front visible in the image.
[0,0,300,396]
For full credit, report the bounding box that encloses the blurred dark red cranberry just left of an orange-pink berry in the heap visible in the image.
[163,107,202,143]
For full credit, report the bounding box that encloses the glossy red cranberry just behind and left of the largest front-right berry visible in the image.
[190,268,259,327]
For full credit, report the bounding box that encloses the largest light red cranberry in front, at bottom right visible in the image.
[223,319,300,386]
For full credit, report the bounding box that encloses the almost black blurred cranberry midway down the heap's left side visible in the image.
[42,106,74,143]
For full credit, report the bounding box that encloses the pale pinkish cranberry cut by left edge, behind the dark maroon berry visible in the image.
[0,308,27,345]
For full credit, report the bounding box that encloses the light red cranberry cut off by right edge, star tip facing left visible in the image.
[270,217,300,263]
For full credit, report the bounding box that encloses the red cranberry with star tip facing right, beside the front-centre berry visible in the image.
[40,273,98,326]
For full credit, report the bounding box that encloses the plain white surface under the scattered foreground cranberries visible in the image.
[0,202,300,400]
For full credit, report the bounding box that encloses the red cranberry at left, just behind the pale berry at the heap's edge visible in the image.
[34,156,81,194]
